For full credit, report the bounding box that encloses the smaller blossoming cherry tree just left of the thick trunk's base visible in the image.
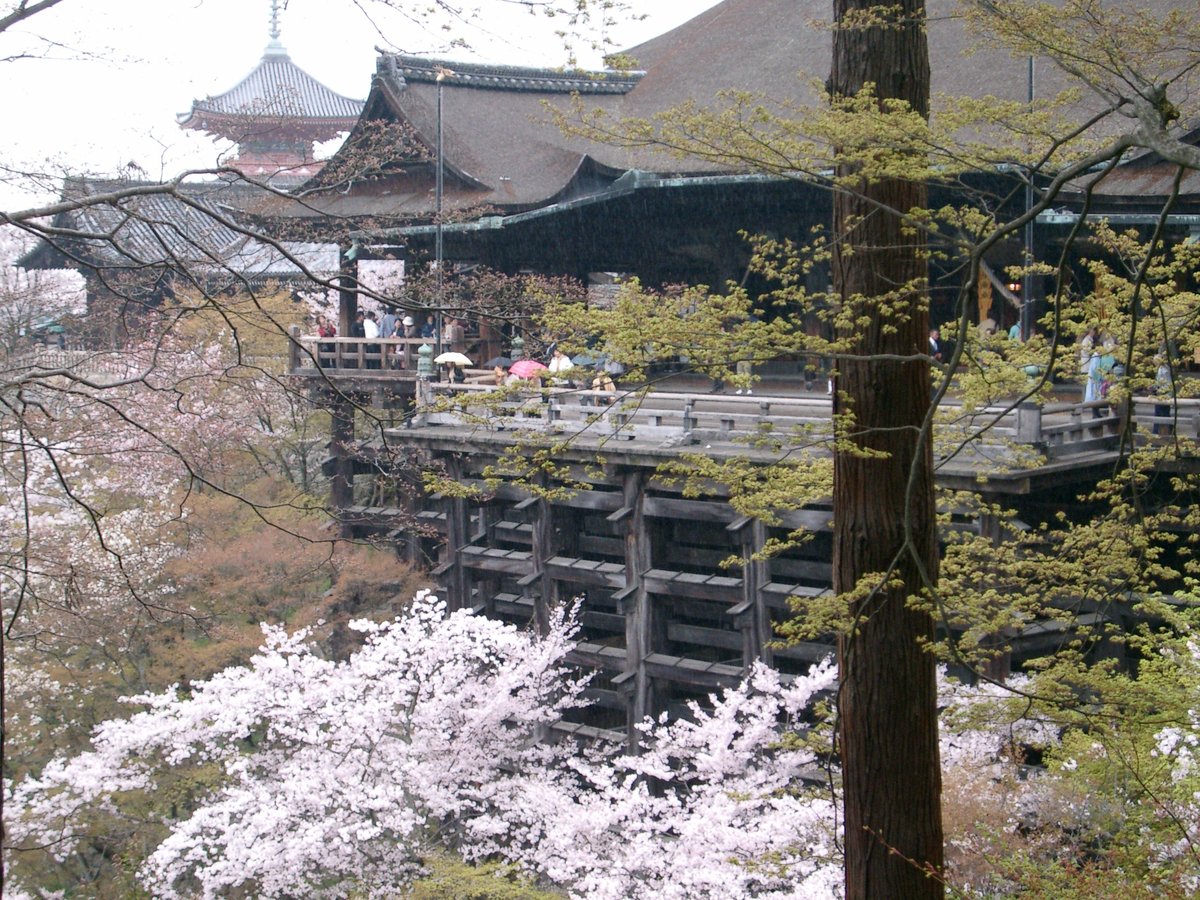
[505,660,842,900]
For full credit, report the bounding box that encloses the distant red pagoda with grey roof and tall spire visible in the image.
[179,0,362,184]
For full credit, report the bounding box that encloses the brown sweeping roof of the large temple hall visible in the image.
[270,0,1190,224]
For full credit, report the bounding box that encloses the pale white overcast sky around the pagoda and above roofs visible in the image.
[0,0,718,209]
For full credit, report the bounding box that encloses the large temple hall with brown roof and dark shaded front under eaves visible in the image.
[272,0,1200,336]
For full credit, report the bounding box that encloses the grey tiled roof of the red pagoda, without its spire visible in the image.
[179,40,362,140]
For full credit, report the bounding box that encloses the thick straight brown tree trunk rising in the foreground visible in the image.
[829,0,943,900]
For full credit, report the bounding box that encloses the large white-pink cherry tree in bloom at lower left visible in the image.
[6,595,583,896]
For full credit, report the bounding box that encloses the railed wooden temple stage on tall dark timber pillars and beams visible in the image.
[292,338,1200,739]
